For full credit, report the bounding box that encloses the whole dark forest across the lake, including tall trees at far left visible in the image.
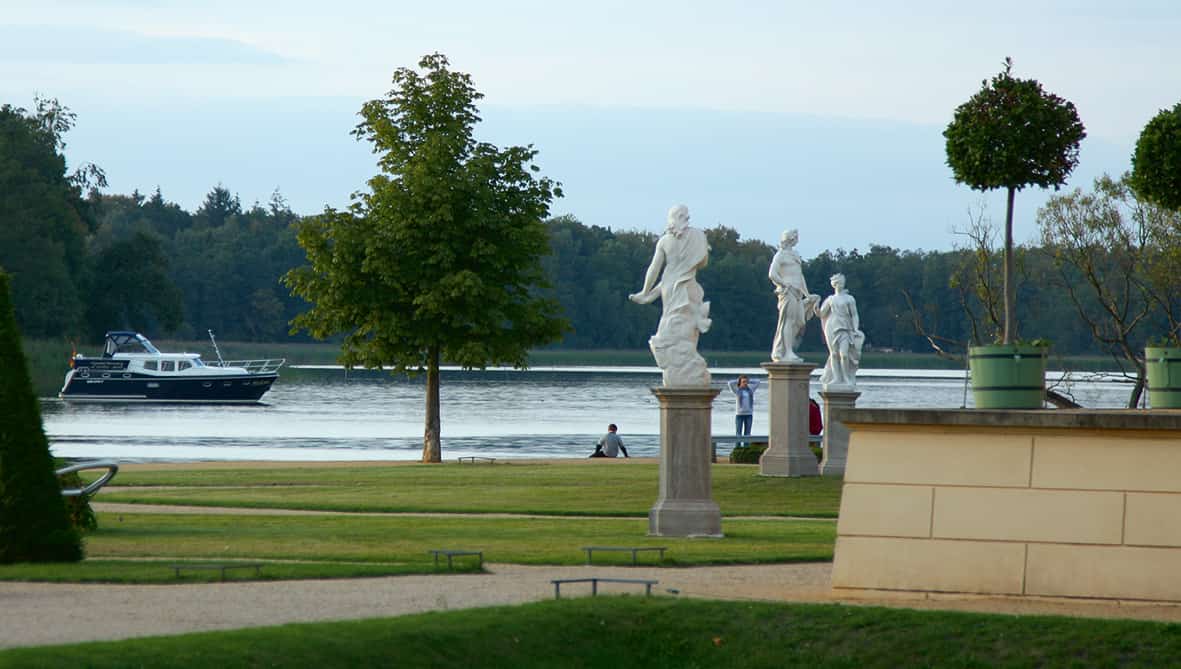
[0,98,1143,355]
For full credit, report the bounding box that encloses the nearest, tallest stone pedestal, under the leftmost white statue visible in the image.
[648,387,722,537]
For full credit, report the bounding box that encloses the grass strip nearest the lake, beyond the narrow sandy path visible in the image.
[98,461,842,519]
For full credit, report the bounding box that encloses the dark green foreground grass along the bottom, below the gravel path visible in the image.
[0,597,1181,669]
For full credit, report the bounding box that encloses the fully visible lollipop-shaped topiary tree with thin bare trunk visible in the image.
[944,58,1087,344]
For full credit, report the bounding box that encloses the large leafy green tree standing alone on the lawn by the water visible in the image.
[283,53,567,462]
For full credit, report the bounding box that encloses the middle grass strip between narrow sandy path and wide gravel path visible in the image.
[86,513,836,565]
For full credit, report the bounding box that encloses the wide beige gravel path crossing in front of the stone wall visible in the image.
[0,563,1181,648]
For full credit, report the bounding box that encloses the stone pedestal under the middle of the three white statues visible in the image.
[758,363,820,476]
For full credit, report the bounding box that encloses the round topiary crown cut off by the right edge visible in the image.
[1130,103,1181,212]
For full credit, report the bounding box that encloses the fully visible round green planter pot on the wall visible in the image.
[968,344,1046,409]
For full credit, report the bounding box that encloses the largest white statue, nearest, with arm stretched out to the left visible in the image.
[627,204,710,387]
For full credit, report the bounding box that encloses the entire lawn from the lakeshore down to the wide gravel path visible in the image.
[0,461,840,583]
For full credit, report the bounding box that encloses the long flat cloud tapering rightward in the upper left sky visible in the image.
[0,25,288,65]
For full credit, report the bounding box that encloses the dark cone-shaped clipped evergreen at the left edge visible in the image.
[0,271,83,564]
